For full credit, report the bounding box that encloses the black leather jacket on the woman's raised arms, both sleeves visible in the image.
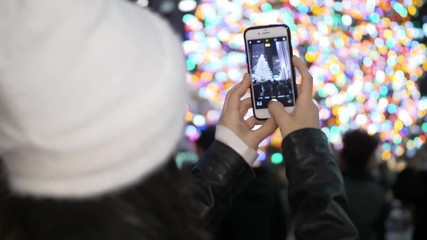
[192,129,358,240]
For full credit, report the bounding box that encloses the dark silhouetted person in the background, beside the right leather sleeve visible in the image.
[340,129,388,240]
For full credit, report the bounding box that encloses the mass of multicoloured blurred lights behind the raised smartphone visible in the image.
[183,0,427,163]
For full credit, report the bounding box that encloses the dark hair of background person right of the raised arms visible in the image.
[341,129,380,170]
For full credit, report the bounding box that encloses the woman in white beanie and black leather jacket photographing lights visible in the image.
[0,0,356,240]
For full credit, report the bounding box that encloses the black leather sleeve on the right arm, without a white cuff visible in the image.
[282,128,358,240]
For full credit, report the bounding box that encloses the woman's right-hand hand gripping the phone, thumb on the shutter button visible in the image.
[268,56,320,138]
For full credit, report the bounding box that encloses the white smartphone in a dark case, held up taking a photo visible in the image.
[244,24,297,120]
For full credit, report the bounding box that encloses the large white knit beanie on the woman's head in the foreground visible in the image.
[0,0,187,198]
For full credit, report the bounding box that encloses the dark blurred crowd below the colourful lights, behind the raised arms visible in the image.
[179,125,427,240]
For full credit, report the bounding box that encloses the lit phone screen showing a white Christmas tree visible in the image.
[248,36,295,109]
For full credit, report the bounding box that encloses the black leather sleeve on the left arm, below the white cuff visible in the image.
[191,141,254,229]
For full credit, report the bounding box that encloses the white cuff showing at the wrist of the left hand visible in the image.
[215,125,258,166]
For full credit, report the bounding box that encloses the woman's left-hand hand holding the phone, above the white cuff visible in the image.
[218,74,277,150]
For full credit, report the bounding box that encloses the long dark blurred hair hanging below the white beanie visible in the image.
[0,158,207,240]
